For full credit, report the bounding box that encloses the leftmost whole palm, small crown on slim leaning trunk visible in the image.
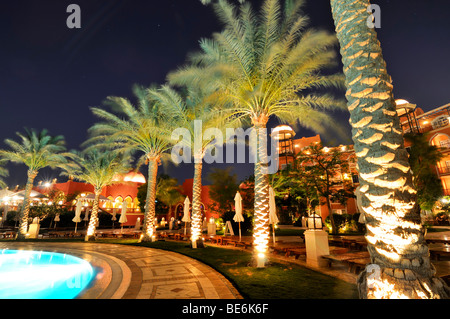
[0,129,67,240]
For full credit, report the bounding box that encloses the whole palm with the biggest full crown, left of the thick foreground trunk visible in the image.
[174,0,345,262]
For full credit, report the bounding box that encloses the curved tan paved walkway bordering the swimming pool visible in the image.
[0,242,242,299]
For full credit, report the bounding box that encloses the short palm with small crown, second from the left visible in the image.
[62,147,131,241]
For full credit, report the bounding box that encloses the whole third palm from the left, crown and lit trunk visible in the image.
[88,86,175,241]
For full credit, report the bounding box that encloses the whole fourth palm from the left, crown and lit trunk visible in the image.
[149,85,232,247]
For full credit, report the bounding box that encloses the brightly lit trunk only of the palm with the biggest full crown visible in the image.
[253,115,270,264]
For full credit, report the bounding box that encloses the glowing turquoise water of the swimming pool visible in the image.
[0,249,95,299]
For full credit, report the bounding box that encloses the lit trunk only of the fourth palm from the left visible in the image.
[191,158,203,247]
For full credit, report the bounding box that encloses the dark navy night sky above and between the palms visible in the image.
[0,0,450,187]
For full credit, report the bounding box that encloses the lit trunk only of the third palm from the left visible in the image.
[142,156,159,242]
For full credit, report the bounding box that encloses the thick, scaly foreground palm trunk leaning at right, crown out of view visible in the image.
[331,0,449,298]
